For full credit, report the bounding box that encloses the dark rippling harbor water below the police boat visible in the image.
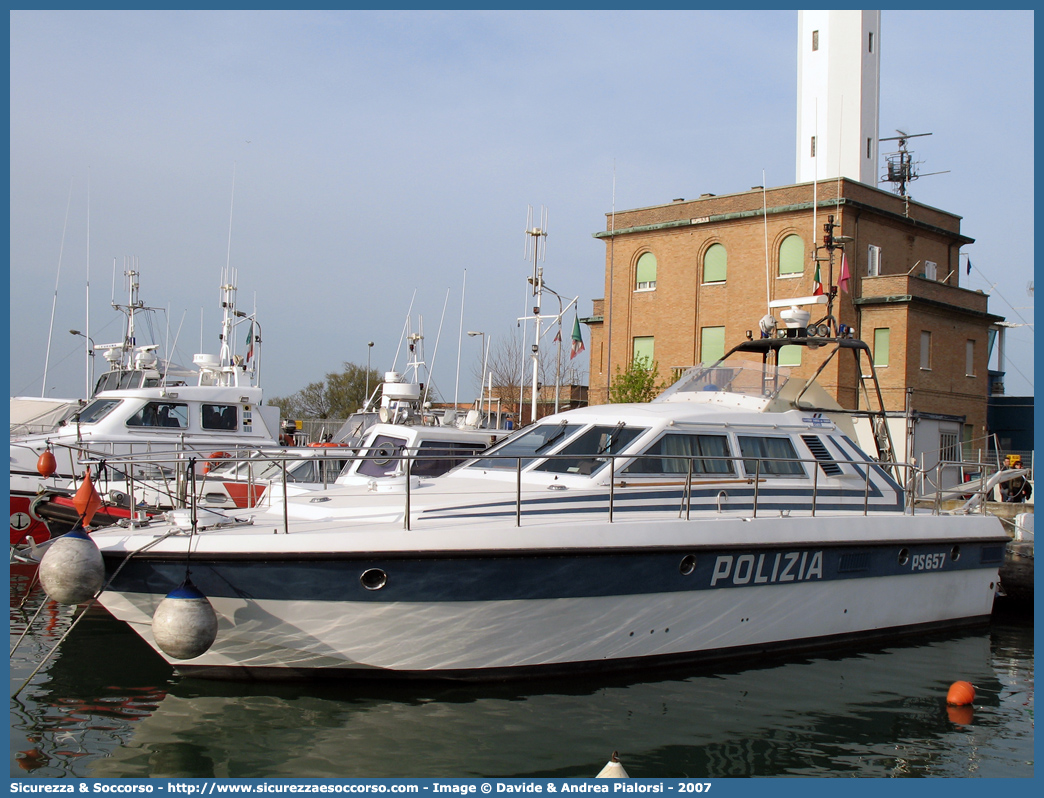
[10,571,1035,779]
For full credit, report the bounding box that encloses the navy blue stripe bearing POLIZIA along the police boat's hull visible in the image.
[105,541,1003,603]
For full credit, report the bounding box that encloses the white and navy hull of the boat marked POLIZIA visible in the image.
[101,516,1003,679]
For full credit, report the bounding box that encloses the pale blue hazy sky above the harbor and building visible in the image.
[10,10,1035,402]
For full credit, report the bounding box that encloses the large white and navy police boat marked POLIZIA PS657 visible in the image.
[83,330,1007,679]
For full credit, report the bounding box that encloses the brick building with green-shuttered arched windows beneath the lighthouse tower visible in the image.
[582,178,1000,463]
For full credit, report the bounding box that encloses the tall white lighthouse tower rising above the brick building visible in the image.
[797,10,881,186]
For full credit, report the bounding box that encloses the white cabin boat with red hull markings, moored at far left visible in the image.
[10,271,279,546]
